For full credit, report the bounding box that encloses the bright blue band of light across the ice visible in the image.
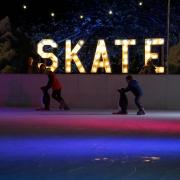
[0,137,180,160]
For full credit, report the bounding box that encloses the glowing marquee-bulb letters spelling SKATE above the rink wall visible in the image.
[37,38,165,74]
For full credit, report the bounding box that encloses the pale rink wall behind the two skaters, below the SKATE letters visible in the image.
[0,74,180,110]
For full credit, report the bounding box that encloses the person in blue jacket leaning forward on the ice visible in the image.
[125,75,145,115]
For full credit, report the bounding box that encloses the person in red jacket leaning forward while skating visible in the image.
[43,71,69,110]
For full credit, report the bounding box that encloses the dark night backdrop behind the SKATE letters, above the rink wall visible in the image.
[0,0,180,74]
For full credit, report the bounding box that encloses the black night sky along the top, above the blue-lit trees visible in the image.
[0,0,179,21]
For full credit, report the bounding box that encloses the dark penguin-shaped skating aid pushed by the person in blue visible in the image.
[113,88,128,115]
